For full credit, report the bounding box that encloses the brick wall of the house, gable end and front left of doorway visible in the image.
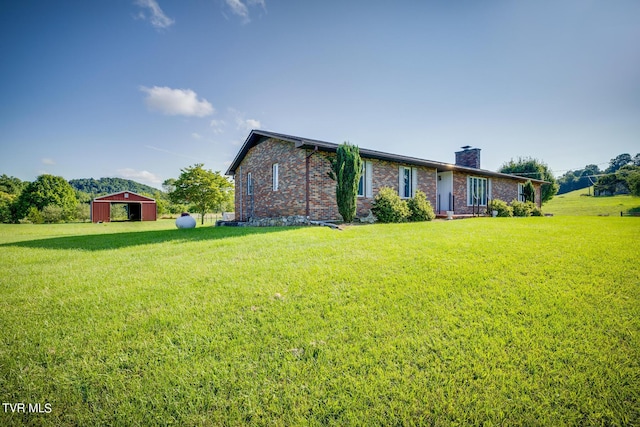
[235,138,437,221]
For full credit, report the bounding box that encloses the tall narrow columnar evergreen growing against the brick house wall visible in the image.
[329,142,362,222]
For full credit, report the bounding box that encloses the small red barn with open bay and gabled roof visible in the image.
[91,191,157,222]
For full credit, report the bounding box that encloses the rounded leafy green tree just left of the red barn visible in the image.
[16,174,78,220]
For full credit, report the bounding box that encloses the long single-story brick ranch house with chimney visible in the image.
[226,130,544,221]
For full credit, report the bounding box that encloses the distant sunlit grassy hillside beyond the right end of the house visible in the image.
[542,187,640,216]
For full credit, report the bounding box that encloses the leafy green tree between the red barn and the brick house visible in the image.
[169,163,233,224]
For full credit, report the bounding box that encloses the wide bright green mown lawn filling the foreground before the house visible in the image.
[0,216,640,426]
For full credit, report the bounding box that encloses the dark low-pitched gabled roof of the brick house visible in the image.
[225,129,546,184]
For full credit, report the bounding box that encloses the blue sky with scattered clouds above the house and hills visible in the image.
[0,0,640,188]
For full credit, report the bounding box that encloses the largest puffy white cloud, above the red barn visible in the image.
[140,86,215,117]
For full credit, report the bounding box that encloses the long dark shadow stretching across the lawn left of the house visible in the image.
[0,227,291,251]
